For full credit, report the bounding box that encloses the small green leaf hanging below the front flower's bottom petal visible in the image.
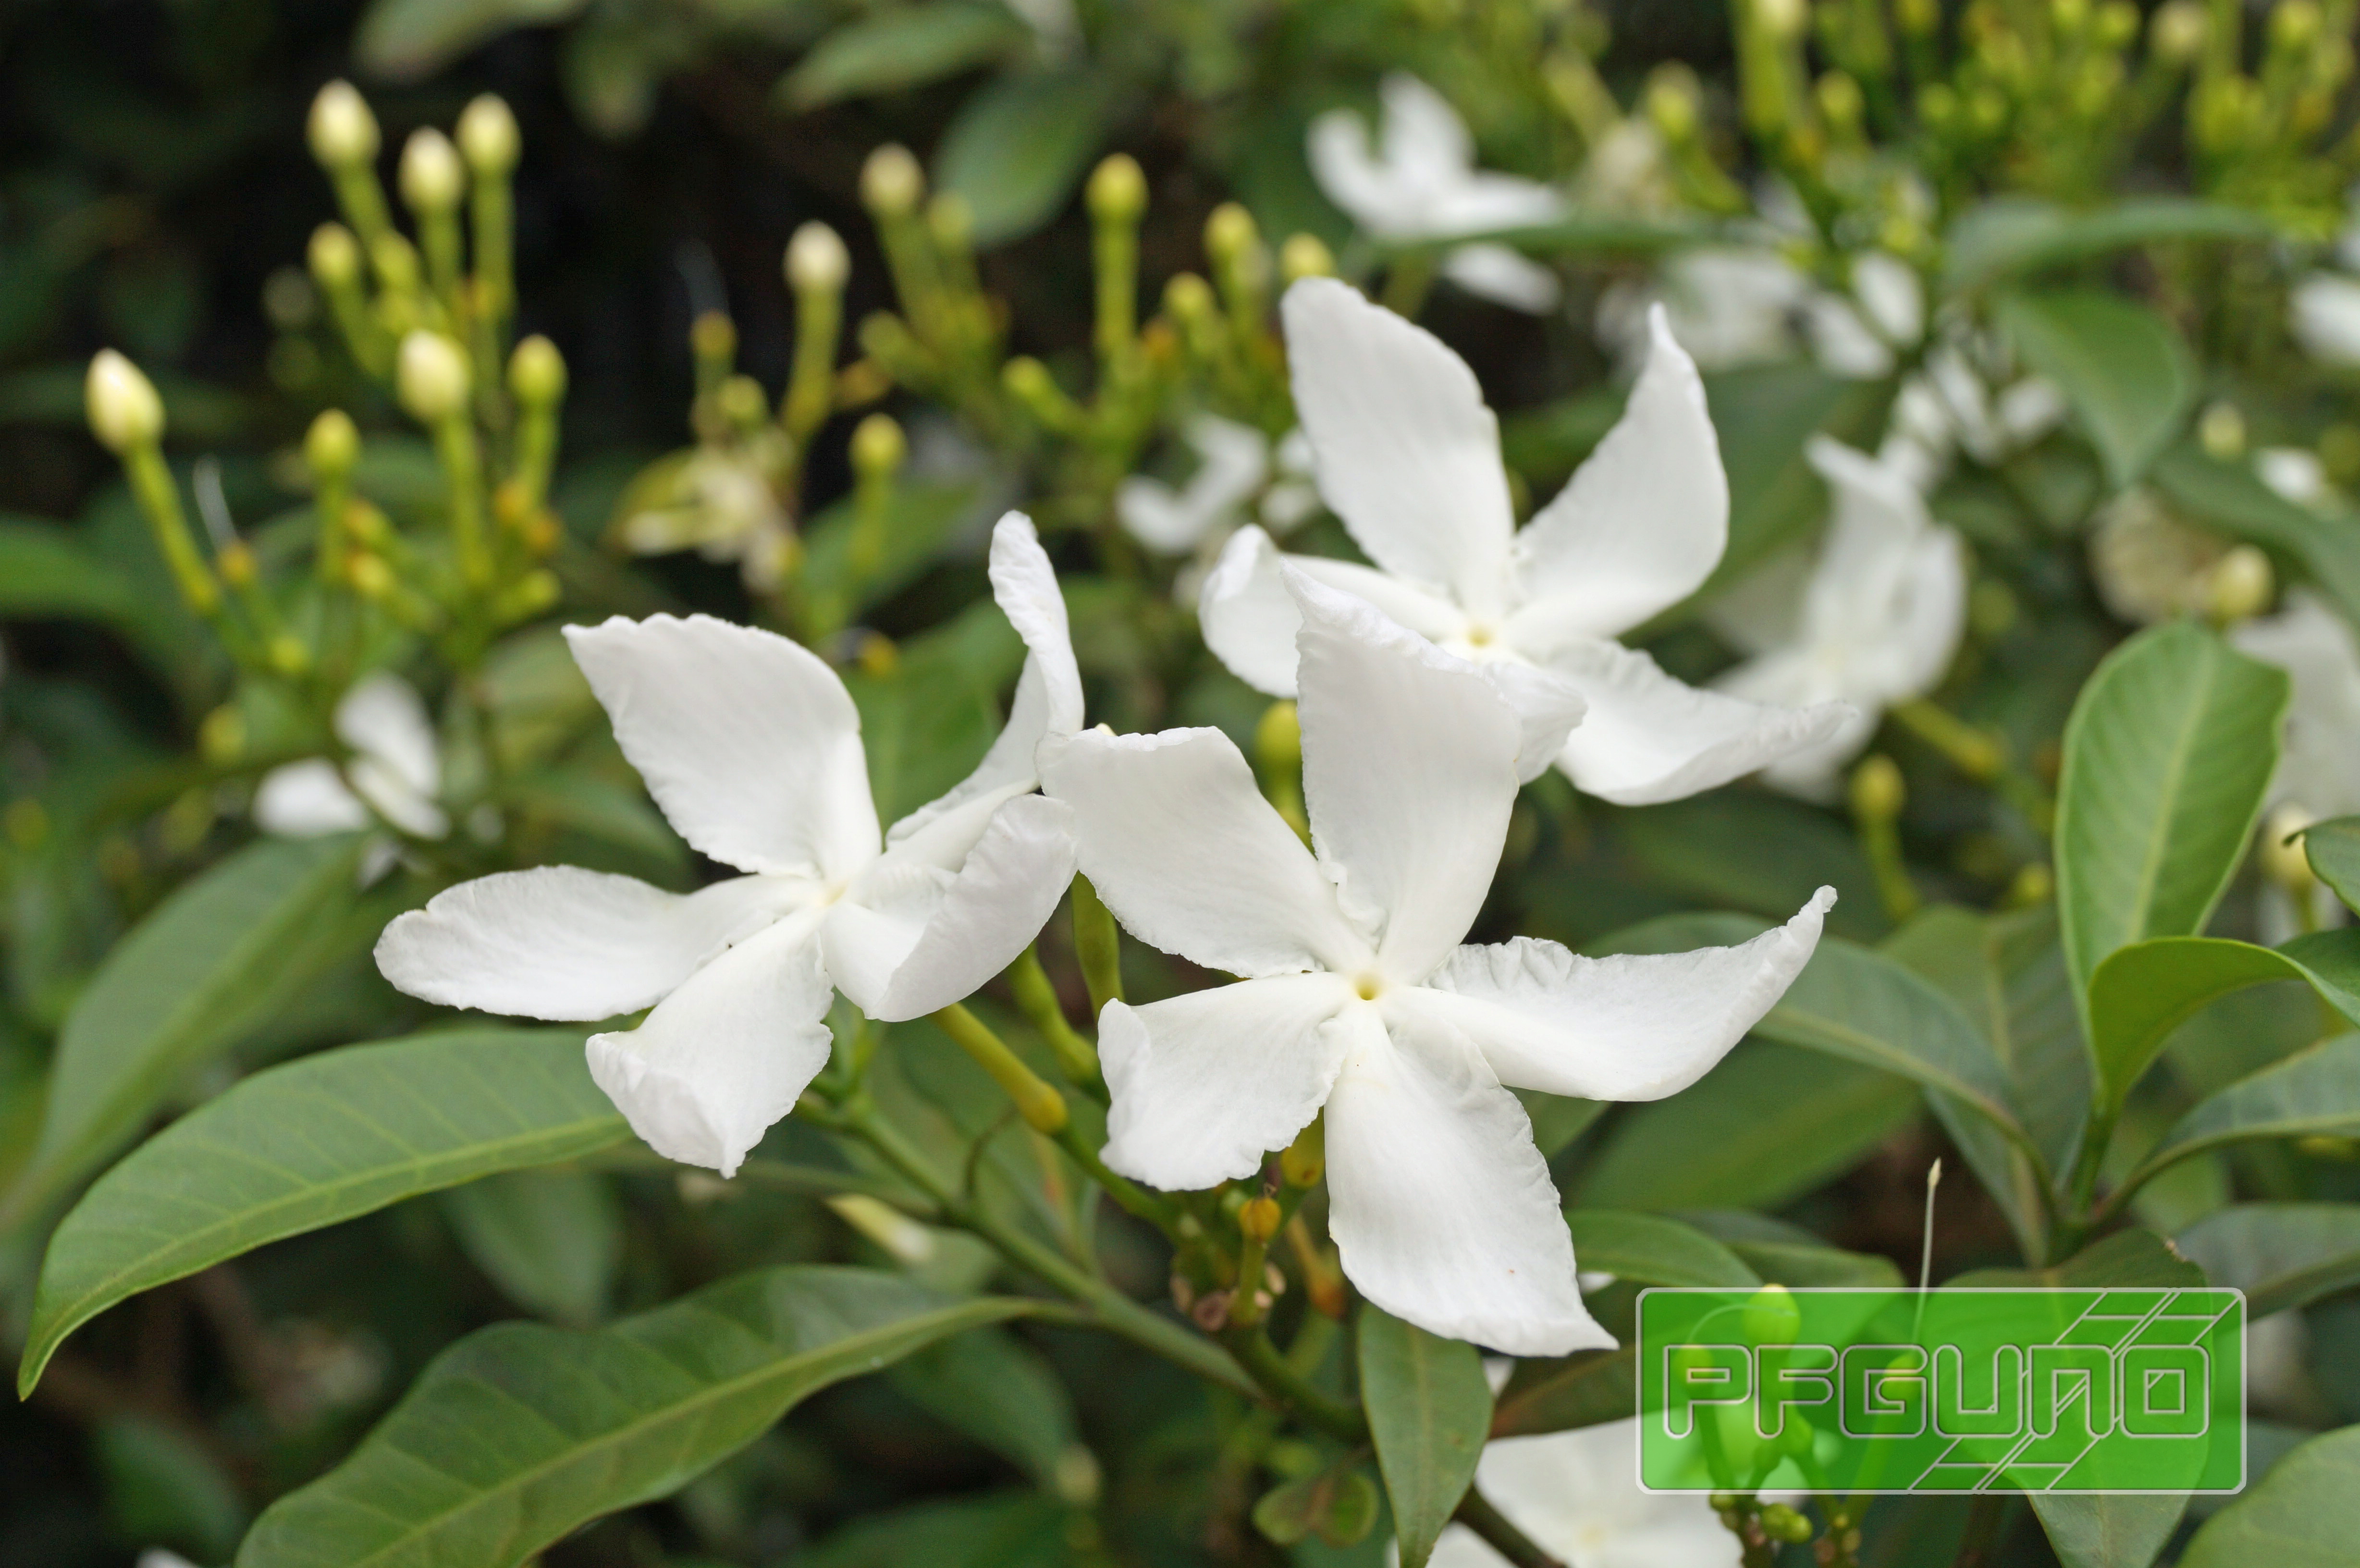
[1357,1303,1491,1568]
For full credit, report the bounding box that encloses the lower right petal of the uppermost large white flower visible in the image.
[1548,642,1850,805]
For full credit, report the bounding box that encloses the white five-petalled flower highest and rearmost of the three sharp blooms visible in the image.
[1199,279,1843,805]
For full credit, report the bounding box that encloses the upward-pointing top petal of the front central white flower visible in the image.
[1286,574,1524,982]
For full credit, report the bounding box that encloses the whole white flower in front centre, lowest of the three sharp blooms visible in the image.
[1043,572,1834,1356]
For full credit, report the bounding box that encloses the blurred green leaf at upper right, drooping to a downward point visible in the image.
[1999,288,2197,489]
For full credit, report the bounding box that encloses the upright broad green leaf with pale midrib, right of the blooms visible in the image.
[2055,621,2287,996]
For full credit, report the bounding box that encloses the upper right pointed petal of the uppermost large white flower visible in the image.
[1508,305,1730,657]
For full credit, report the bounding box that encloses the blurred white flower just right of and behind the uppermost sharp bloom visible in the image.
[1713,437,1966,800]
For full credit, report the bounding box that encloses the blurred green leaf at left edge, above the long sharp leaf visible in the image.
[0,833,387,1221]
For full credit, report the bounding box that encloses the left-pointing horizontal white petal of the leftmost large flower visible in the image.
[378,867,817,1020]
